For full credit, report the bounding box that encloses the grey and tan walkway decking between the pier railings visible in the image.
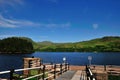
[55,66,87,80]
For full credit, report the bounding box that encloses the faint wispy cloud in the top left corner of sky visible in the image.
[0,0,24,7]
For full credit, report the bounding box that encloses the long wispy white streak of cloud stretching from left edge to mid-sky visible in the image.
[0,15,71,28]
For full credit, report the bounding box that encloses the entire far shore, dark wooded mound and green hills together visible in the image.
[0,36,120,53]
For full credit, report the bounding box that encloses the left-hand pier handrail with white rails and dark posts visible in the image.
[0,64,69,80]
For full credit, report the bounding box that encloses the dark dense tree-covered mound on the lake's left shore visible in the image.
[0,37,33,53]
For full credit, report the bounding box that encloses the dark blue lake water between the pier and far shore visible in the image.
[0,52,120,71]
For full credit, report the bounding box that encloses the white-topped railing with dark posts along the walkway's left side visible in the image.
[0,63,69,80]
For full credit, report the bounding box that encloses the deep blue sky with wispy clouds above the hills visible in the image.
[0,0,120,42]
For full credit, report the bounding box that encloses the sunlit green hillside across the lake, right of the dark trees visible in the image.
[34,36,120,52]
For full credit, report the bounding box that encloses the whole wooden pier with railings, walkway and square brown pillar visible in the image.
[0,58,120,80]
